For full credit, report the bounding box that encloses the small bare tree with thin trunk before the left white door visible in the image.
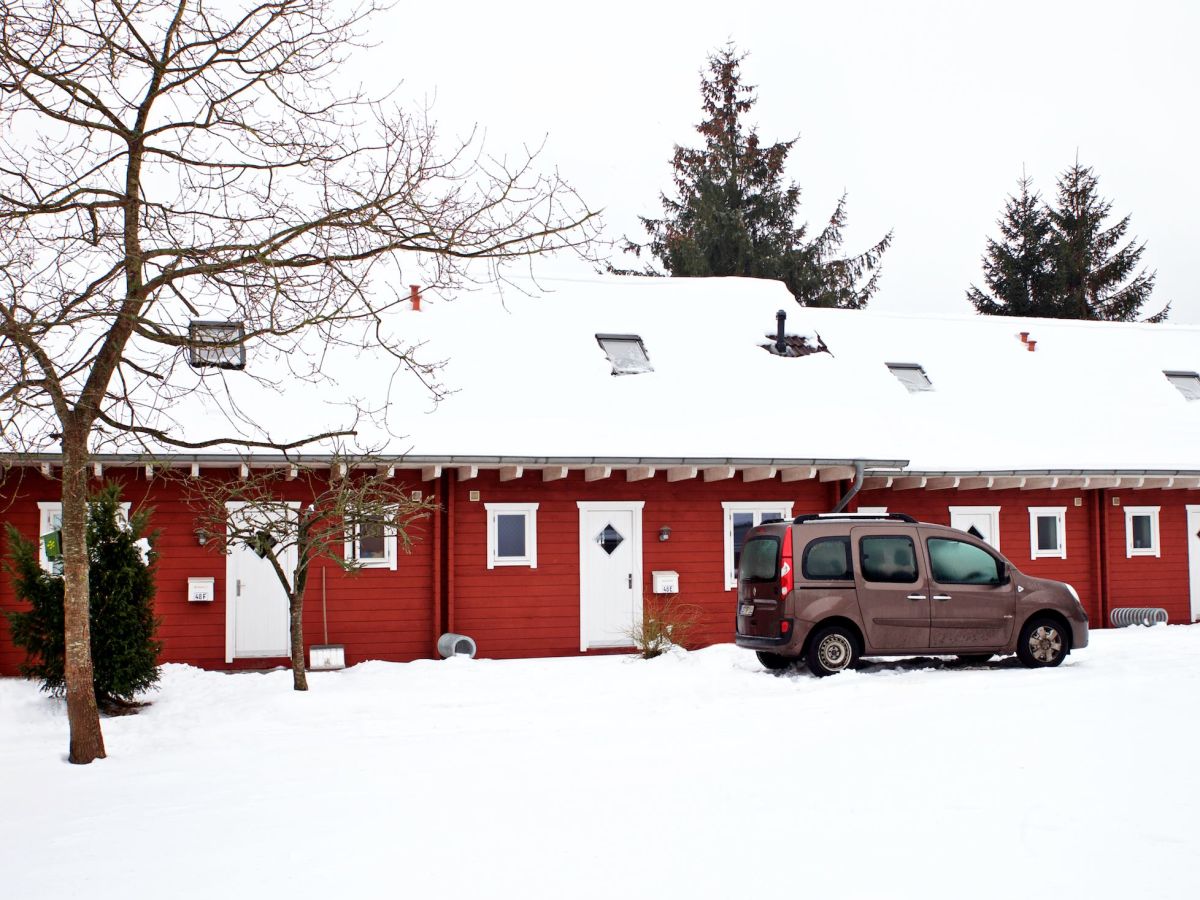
[186,461,437,691]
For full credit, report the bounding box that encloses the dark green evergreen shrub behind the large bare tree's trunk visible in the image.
[5,485,162,713]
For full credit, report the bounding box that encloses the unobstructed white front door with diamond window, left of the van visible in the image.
[578,500,643,650]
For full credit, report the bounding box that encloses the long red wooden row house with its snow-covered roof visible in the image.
[0,278,1200,673]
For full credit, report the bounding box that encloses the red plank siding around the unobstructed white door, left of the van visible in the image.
[454,472,838,658]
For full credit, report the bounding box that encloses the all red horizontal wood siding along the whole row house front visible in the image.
[0,468,1200,674]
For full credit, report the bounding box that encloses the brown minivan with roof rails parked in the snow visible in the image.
[737,514,1087,676]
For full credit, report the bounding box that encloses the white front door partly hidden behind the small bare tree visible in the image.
[226,503,295,662]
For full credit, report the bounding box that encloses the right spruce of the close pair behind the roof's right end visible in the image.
[1049,160,1171,322]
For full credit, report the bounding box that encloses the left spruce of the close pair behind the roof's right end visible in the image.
[967,176,1057,317]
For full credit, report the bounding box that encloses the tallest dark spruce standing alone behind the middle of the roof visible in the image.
[628,47,892,308]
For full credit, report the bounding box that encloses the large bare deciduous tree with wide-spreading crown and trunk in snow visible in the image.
[0,0,593,763]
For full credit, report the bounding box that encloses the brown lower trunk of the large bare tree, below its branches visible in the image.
[62,434,104,764]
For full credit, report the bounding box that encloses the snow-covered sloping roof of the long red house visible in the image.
[11,277,1200,473]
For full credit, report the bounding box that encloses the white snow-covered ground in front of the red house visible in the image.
[0,626,1200,900]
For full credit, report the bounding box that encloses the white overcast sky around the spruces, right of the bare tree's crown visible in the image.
[352,0,1200,323]
